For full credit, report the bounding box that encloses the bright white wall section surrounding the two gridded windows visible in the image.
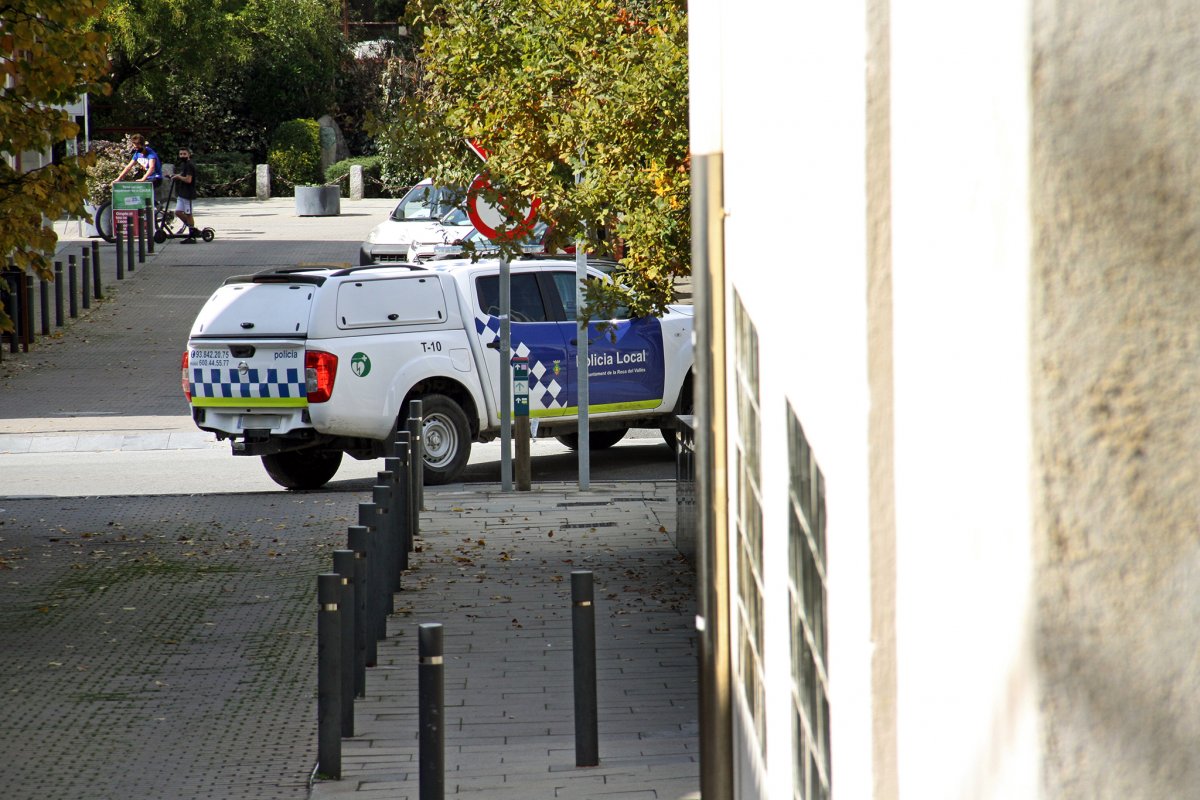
[710,1,871,799]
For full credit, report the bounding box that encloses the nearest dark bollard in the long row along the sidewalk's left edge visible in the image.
[317,572,342,778]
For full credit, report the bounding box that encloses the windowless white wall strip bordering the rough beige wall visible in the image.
[890,0,1038,798]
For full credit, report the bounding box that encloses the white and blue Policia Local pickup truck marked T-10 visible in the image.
[182,258,692,489]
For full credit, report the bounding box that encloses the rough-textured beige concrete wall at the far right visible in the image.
[1031,0,1200,799]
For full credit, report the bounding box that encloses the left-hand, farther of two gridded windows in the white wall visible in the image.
[733,293,767,763]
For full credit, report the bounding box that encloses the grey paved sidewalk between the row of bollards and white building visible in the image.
[313,482,700,800]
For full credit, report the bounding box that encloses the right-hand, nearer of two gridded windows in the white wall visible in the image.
[787,407,833,800]
